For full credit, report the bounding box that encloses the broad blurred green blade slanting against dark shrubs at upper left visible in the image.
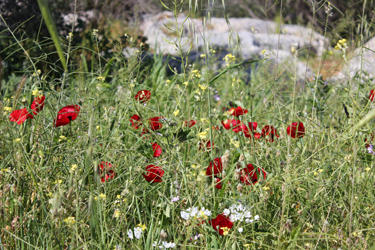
[38,0,68,71]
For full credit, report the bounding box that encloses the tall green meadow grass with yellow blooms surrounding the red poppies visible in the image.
[0,0,375,249]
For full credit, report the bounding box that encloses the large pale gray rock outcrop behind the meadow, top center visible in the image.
[140,11,329,78]
